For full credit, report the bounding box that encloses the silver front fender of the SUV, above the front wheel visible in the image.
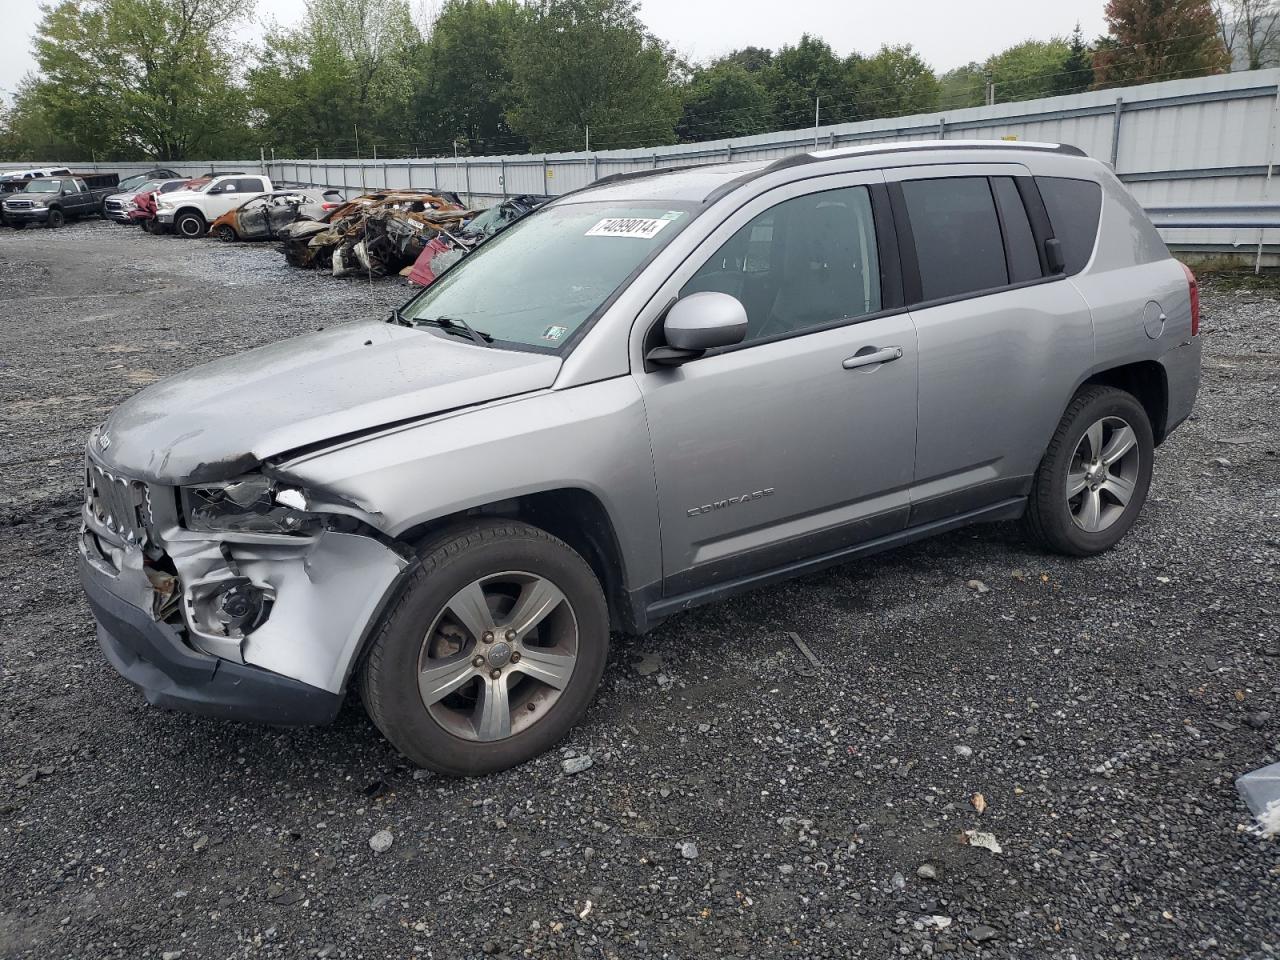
[270,376,662,599]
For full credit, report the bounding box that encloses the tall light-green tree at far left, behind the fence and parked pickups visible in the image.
[23,0,251,160]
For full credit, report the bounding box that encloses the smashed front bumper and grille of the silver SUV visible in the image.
[79,458,411,724]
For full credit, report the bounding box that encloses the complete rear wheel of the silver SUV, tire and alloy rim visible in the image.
[1025,387,1156,557]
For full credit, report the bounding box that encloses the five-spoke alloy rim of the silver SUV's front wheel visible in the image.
[417,571,579,742]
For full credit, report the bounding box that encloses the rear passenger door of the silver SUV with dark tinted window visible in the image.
[886,164,1093,525]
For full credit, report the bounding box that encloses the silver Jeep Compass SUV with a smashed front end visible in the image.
[81,142,1201,774]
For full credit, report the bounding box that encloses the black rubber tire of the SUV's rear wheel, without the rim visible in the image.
[1037,389,1156,557]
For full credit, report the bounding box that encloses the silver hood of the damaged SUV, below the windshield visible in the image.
[93,320,561,484]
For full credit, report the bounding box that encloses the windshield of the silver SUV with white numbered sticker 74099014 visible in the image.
[402,201,692,351]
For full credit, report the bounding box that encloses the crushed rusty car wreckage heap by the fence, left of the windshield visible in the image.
[279,191,474,276]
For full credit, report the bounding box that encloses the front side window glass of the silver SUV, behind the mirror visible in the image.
[680,187,881,342]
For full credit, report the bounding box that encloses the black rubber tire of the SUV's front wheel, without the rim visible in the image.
[365,532,609,776]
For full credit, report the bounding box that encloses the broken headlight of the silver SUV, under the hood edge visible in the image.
[182,476,321,534]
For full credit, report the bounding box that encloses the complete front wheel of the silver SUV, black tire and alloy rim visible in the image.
[358,521,609,777]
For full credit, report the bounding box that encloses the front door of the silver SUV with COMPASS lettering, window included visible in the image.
[632,173,916,596]
